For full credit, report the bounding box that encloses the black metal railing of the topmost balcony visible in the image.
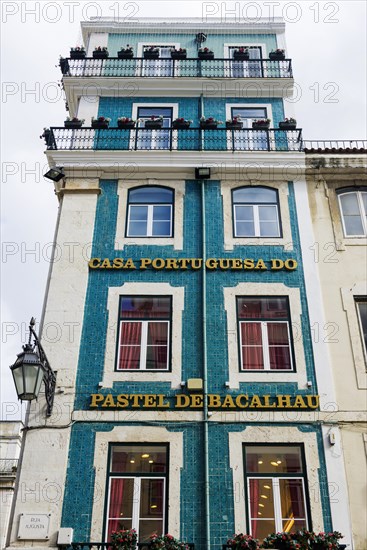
[60,57,293,78]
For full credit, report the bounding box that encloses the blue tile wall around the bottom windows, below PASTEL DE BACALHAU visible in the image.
[61,421,332,550]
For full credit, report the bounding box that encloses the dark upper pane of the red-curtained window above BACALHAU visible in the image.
[237,297,288,319]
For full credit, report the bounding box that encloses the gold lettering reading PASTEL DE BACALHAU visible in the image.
[89,393,320,410]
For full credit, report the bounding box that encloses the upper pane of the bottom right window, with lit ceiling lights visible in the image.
[245,445,302,474]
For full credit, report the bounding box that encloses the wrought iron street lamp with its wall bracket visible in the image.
[10,317,56,416]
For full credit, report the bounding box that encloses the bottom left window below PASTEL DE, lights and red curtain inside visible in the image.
[106,443,168,542]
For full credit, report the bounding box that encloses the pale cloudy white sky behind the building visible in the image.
[0,0,367,420]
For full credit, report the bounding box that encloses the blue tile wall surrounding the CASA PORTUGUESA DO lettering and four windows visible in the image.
[76,180,317,409]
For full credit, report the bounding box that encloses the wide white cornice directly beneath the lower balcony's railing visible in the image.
[46,149,305,180]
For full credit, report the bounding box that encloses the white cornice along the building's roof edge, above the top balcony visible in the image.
[81,16,285,44]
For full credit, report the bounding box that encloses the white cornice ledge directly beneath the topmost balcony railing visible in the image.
[63,77,294,116]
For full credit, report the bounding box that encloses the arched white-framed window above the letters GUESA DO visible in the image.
[232,187,280,237]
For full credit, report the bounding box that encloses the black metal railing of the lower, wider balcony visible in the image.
[44,127,302,152]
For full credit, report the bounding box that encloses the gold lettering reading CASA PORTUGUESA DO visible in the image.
[88,258,298,271]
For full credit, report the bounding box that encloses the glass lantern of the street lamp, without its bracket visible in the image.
[10,344,44,401]
